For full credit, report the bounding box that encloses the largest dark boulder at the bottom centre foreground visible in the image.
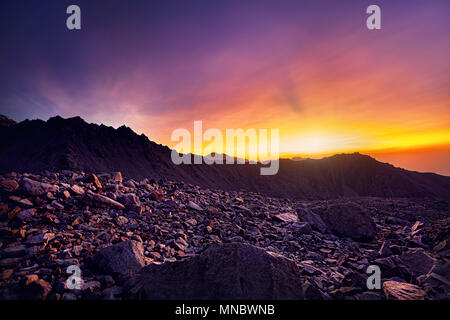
[126,243,303,299]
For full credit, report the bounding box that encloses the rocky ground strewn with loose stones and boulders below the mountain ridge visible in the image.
[0,170,450,300]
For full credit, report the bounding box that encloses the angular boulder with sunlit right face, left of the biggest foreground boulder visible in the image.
[92,240,145,275]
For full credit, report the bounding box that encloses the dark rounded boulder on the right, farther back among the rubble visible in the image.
[321,203,377,241]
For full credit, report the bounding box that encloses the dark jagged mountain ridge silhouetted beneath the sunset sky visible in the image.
[0,116,450,199]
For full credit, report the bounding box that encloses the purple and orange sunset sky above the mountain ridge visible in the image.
[0,0,450,175]
